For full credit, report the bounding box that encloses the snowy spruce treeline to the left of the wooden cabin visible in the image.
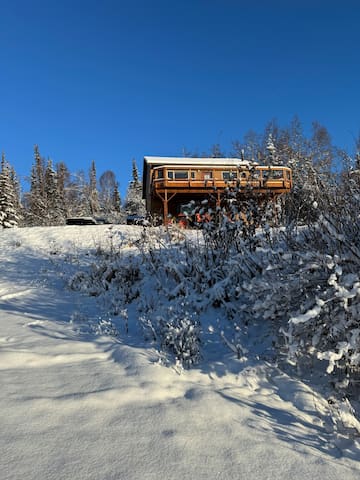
[0,145,144,228]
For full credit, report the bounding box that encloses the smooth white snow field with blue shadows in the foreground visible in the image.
[0,226,360,480]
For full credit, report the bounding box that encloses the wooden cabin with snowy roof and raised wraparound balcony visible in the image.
[143,157,292,223]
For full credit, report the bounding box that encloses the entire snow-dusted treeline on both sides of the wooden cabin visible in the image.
[0,117,360,227]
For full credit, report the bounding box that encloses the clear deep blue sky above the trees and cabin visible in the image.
[0,0,360,195]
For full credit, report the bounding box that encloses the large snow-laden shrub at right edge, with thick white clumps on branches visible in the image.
[235,208,360,396]
